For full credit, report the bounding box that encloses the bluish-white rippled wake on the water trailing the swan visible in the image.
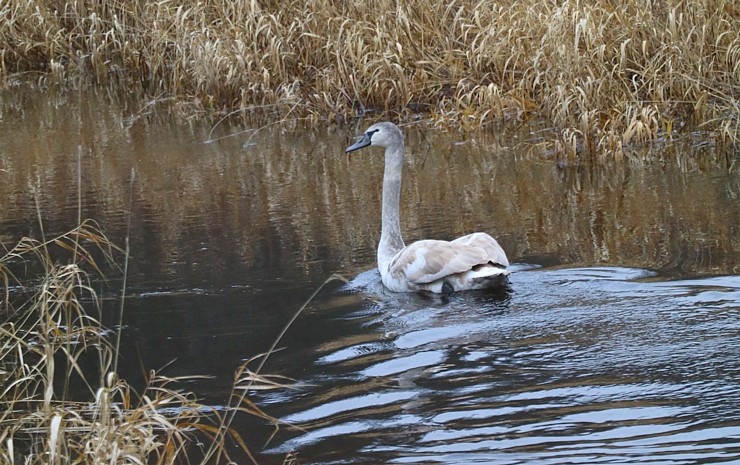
[264,268,740,465]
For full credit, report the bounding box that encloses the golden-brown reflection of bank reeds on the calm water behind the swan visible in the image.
[0,88,740,287]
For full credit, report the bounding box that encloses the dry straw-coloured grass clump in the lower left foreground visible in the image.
[0,222,282,464]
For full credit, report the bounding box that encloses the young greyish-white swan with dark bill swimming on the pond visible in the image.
[344,122,509,294]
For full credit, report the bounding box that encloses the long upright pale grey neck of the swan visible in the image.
[378,141,404,266]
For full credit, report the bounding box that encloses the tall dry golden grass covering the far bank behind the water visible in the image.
[0,0,740,157]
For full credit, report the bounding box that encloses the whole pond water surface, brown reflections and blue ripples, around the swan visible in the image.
[0,86,740,464]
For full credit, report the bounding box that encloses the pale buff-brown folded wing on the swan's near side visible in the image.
[388,240,490,284]
